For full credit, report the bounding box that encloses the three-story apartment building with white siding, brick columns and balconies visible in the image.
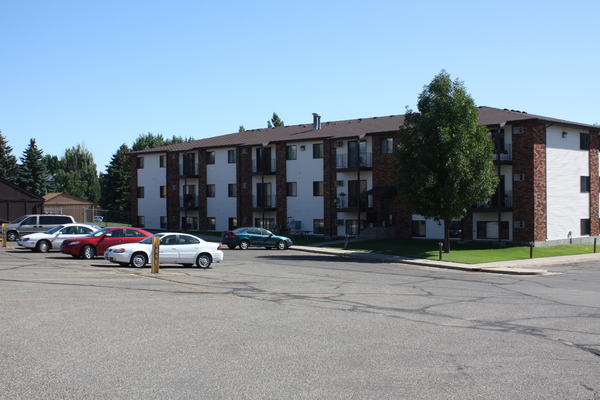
[131,107,600,245]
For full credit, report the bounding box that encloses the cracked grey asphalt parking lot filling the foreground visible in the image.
[0,245,600,399]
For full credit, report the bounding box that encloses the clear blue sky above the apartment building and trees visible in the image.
[0,0,600,172]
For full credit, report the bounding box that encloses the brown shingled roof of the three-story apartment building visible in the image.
[129,106,600,154]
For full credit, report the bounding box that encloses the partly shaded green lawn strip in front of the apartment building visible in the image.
[316,239,600,264]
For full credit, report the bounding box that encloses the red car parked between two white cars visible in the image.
[60,227,152,260]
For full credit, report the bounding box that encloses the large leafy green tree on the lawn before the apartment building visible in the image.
[395,70,498,252]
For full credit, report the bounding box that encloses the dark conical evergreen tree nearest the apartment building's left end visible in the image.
[100,144,131,222]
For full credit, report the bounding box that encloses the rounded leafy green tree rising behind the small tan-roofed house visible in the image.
[55,145,100,203]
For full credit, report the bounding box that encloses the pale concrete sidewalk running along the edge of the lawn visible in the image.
[292,241,600,275]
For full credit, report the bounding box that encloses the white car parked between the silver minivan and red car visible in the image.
[17,223,100,253]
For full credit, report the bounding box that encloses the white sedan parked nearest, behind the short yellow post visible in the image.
[104,232,223,268]
